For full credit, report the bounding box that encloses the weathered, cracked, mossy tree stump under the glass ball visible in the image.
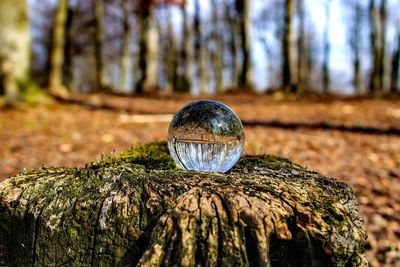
[0,143,366,266]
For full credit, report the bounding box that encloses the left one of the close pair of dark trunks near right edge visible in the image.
[369,0,380,94]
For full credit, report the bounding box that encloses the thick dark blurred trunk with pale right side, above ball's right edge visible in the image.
[236,0,253,89]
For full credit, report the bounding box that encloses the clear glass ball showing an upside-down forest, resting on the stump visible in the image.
[168,100,244,173]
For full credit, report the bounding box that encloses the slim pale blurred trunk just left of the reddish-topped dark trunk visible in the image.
[119,1,131,93]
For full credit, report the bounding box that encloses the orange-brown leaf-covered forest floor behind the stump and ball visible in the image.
[0,95,400,266]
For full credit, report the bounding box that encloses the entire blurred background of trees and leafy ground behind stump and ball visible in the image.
[0,0,400,266]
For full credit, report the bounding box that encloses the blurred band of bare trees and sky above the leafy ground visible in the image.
[0,0,400,103]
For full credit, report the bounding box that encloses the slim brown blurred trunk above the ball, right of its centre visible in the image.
[212,0,224,94]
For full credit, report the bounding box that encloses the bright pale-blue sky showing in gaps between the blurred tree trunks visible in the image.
[30,0,400,94]
